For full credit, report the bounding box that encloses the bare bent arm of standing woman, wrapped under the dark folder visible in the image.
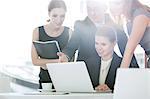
[31,28,59,69]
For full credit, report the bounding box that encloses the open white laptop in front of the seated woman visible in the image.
[46,61,111,93]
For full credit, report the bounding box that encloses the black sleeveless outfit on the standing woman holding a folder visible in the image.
[39,26,69,88]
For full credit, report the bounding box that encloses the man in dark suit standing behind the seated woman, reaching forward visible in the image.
[59,0,139,68]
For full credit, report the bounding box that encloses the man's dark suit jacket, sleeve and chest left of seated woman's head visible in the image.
[64,17,97,61]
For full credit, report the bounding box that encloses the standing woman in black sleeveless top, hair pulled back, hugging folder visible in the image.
[31,0,70,88]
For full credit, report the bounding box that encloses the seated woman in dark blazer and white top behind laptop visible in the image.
[87,26,122,91]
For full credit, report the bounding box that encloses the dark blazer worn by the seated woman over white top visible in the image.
[86,53,122,90]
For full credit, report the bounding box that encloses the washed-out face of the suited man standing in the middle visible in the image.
[87,0,106,23]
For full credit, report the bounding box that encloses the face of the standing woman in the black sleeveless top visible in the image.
[49,8,66,28]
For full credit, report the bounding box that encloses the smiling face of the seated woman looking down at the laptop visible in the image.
[95,36,115,60]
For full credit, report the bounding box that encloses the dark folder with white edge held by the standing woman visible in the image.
[33,41,61,59]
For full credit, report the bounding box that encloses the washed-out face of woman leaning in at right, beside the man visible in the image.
[109,0,124,16]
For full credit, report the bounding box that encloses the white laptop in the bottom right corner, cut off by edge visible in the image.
[113,68,150,99]
